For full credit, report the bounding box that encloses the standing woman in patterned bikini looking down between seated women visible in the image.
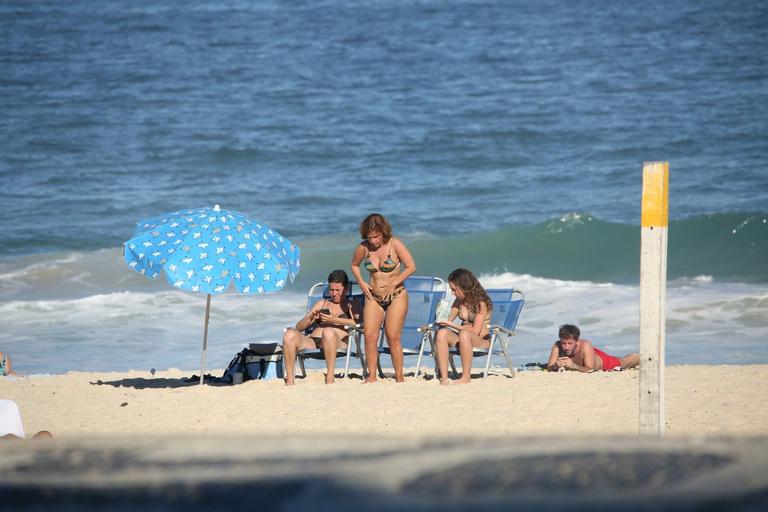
[352,213,416,382]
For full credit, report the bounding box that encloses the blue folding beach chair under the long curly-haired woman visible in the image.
[444,288,525,379]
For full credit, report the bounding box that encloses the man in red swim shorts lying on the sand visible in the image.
[547,324,640,372]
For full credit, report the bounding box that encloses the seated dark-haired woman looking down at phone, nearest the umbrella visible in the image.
[283,270,362,386]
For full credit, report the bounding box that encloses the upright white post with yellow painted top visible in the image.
[640,162,669,436]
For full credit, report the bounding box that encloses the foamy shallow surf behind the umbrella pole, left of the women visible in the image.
[0,290,306,373]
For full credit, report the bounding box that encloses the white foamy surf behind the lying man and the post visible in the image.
[480,273,768,363]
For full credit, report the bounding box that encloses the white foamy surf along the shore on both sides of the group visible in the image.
[0,266,768,373]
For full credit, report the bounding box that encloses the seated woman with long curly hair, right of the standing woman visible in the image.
[435,268,493,385]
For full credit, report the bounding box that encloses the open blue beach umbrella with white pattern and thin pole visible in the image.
[123,205,301,384]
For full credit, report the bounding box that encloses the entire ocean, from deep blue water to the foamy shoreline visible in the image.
[0,0,768,373]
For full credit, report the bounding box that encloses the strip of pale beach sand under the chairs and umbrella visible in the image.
[0,365,768,438]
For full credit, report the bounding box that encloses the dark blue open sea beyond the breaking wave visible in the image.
[0,0,768,256]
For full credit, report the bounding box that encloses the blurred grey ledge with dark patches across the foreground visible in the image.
[0,436,768,512]
